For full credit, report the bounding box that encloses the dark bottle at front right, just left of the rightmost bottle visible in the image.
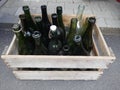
[71,35,89,56]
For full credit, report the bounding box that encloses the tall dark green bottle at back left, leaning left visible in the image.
[23,6,36,33]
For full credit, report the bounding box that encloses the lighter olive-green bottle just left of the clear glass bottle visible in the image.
[67,18,77,46]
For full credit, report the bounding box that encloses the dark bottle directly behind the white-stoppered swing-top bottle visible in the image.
[51,13,65,45]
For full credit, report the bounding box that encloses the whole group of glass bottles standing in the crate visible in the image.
[12,5,96,56]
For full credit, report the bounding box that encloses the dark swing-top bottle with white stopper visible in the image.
[48,25,62,55]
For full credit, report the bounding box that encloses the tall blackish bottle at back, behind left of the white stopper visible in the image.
[41,5,51,47]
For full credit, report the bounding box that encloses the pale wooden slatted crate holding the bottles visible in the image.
[1,15,115,80]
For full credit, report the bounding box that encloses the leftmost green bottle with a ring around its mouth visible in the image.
[12,24,29,55]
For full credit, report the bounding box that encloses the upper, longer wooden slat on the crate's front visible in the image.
[2,55,113,69]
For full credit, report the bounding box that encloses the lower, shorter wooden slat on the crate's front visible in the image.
[13,71,103,80]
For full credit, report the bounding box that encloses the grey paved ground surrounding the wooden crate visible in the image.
[0,0,120,90]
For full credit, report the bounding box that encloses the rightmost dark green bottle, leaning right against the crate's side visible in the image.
[82,17,96,53]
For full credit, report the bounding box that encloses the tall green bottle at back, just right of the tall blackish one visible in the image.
[56,6,66,39]
